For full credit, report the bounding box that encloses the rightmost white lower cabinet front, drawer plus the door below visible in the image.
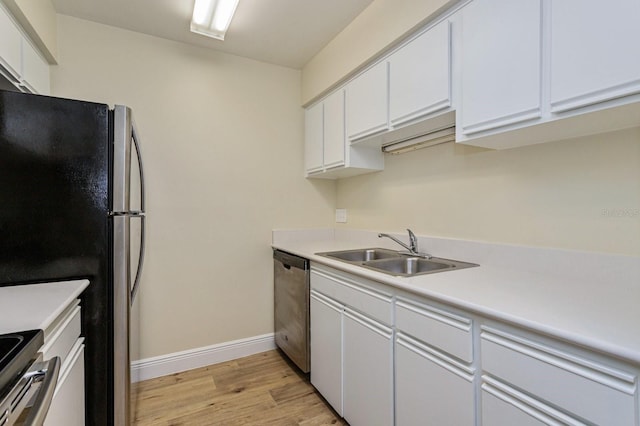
[480,326,640,426]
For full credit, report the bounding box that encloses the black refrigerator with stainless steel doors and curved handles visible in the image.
[0,91,145,426]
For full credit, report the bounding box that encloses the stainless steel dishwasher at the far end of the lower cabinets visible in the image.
[273,250,310,373]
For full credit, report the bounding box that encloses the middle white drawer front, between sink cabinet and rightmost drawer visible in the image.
[396,298,473,363]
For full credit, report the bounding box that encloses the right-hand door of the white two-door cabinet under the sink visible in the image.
[343,308,393,426]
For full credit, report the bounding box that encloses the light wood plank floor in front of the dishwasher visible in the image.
[136,350,347,426]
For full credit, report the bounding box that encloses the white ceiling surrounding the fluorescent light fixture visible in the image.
[52,0,373,69]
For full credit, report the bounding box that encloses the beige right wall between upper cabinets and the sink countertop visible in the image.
[337,128,640,256]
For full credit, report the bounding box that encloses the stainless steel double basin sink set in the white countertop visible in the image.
[316,248,478,277]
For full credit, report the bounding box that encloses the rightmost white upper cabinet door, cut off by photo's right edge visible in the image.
[551,0,640,112]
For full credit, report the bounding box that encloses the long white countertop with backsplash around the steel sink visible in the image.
[272,230,640,363]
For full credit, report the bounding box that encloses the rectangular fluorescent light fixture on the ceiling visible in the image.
[191,0,239,40]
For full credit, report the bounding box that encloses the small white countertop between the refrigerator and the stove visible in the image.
[0,280,89,334]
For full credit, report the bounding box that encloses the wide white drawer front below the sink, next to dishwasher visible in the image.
[311,270,392,325]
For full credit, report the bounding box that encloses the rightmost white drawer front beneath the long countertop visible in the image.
[480,327,637,425]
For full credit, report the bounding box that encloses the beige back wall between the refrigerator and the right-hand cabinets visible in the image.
[52,15,335,358]
